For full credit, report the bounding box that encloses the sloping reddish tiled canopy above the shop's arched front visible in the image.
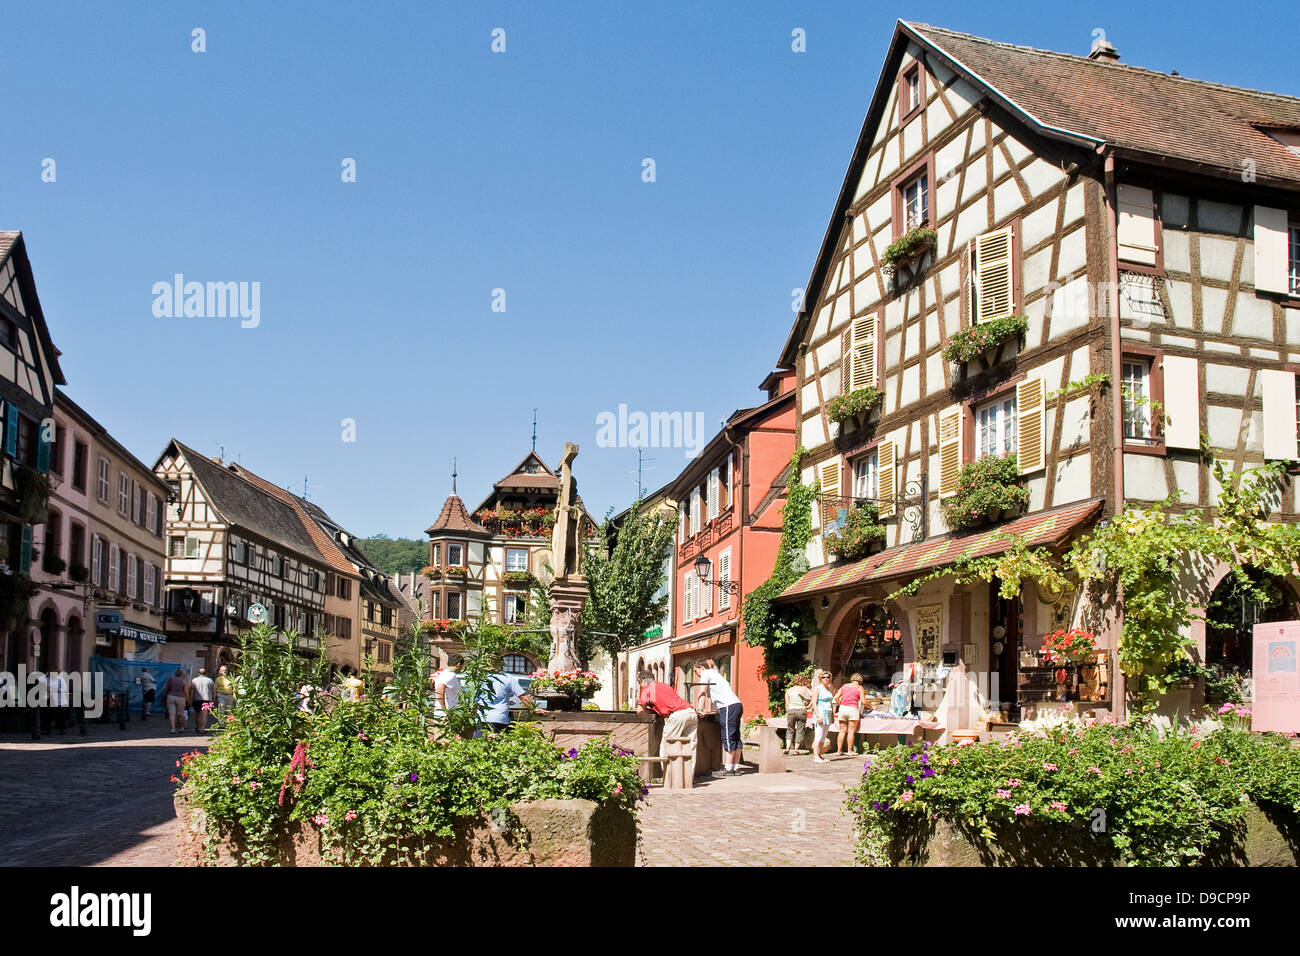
[777,498,1101,601]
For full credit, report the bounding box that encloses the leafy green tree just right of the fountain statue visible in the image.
[580,499,675,659]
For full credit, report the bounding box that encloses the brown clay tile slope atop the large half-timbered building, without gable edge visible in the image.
[904,23,1300,183]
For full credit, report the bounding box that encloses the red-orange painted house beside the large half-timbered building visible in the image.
[670,372,798,717]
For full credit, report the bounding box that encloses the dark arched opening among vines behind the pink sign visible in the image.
[1205,567,1300,676]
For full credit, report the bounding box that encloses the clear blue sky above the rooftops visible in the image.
[0,0,1300,537]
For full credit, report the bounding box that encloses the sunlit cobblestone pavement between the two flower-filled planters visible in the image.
[638,756,862,866]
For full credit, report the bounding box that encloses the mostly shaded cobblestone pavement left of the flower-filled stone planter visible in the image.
[0,717,207,866]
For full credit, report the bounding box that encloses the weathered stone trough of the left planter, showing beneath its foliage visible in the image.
[176,790,637,866]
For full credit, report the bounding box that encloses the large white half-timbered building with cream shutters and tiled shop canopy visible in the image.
[779,22,1300,717]
